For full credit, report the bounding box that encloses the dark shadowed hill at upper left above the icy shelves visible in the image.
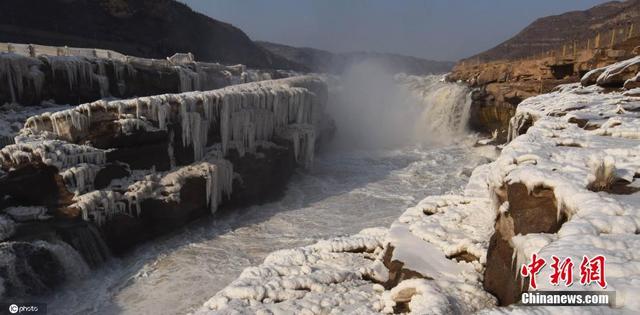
[0,0,306,70]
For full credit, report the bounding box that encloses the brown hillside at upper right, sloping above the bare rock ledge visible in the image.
[468,0,640,61]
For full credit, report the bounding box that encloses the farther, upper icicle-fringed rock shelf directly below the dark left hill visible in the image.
[0,44,287,105]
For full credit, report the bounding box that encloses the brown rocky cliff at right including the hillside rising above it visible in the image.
[448,1,640,142]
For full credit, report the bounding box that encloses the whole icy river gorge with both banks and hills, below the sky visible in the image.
[0,0,640,314]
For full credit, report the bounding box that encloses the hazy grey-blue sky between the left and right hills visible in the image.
[182,0,605,60]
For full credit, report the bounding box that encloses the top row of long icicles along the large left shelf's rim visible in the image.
[20,77,323,165]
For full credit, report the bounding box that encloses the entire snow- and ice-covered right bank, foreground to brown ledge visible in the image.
[197,59,640,314]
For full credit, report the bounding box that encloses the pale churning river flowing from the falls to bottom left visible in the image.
[46,73,486,314]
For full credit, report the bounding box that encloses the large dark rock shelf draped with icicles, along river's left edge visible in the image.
[0,76,332,296]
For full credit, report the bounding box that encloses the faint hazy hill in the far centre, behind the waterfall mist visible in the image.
[256,42,454,74]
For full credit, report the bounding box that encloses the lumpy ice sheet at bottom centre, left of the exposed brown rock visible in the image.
[198,157,495,314]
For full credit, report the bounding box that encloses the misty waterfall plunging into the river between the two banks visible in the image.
[327,62,471,149]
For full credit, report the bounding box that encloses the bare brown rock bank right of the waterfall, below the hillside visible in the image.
[447,36,640,143]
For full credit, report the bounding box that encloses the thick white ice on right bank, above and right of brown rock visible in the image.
[489,80,640,314]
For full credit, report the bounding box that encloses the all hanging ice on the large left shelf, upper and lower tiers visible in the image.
[5,76,327,230]
